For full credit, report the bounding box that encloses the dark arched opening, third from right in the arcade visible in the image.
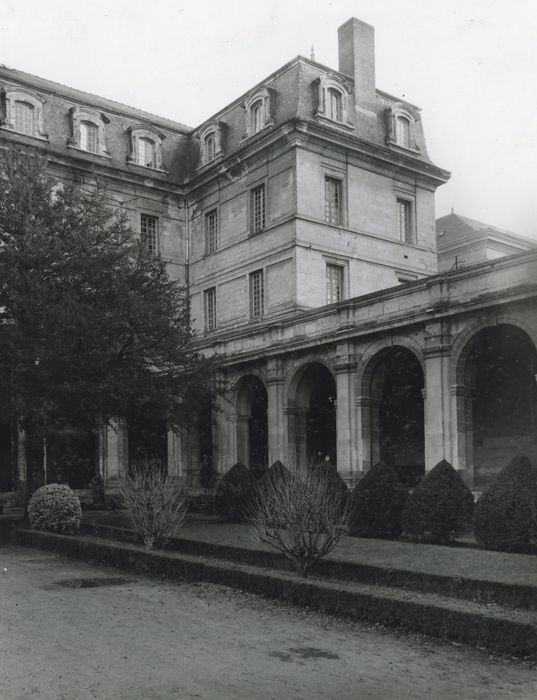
[289,362,337,465]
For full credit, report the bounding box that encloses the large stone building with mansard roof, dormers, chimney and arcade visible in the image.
[0,19,537,498]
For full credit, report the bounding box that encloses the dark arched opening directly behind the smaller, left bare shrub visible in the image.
[127,403,168,467]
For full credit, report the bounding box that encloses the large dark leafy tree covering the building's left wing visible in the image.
[0,150,219,486]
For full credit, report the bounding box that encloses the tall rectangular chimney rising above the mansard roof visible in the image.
[337,17,376,104]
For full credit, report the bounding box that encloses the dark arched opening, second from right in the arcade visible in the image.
[370,346,425,486]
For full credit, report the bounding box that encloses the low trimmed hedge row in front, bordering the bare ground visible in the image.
[11,530,537,656]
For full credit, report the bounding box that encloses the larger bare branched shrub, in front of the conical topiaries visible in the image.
[249,467,350,576]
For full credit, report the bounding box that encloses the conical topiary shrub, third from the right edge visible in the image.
[351,462,408,539]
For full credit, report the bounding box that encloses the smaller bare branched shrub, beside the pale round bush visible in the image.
[121,460,188,549]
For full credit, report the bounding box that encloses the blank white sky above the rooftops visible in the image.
[0,0,537,239]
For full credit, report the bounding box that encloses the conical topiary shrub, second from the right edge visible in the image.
[403,459,474,544]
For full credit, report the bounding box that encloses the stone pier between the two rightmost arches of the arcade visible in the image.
[424,321,453,470]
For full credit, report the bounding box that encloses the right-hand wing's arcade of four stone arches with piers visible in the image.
[214,322,537,490]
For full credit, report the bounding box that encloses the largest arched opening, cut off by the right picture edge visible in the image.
[464,324,537,489]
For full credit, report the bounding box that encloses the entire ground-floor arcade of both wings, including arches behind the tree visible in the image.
[0,314,537,491]
